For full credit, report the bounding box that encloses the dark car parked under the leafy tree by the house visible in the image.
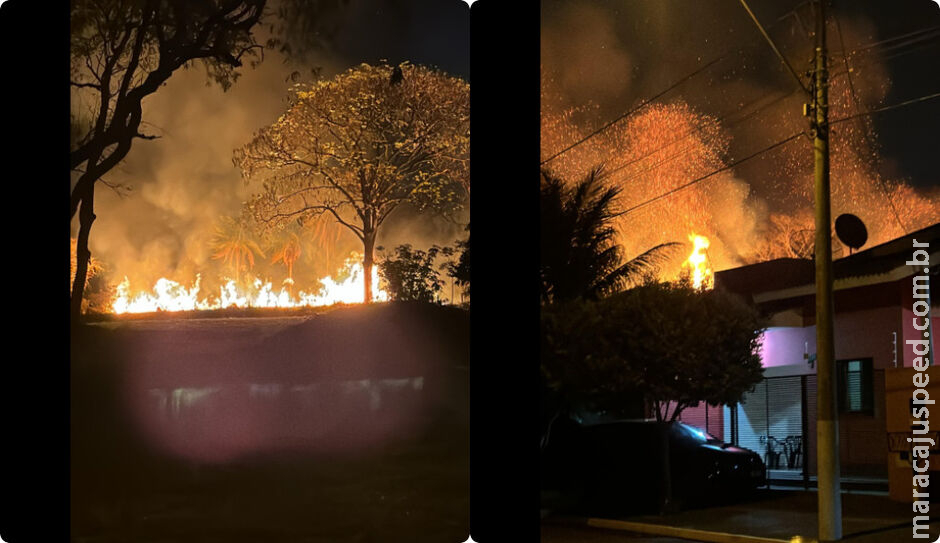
[542,418,766,512]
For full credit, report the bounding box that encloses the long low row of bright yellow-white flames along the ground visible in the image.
[111,254,388,314]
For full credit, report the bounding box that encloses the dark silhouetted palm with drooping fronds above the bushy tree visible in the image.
[539,169,679,303]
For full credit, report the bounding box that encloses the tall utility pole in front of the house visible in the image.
[810,0,842,541]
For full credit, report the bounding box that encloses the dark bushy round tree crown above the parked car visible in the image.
[541,281,765,421]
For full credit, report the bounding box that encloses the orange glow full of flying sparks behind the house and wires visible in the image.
[540,62,940,278]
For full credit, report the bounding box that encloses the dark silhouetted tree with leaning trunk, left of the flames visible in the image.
[69,0,266,318]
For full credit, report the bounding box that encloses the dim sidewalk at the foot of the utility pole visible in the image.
[568,490,928,543]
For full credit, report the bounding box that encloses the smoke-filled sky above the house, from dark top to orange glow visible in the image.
[541,0,940,273]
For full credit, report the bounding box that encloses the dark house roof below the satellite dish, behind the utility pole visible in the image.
[715,223,940,298]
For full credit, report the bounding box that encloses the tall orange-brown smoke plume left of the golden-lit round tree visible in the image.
[90,52,312,284]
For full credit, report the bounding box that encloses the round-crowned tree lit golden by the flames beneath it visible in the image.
[235,64,470,303]
